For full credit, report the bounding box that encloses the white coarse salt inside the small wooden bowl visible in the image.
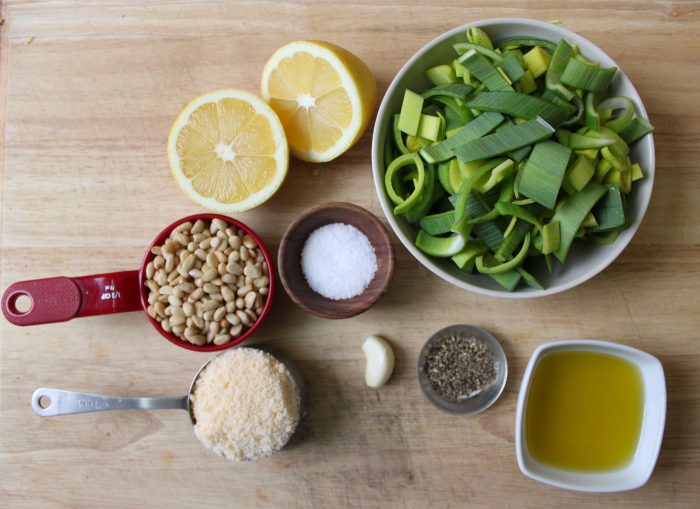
[301,223,377,300]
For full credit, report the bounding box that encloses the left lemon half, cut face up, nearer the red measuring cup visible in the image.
[168,89,289,214]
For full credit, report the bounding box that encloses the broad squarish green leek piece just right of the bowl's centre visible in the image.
[518,141,571,209]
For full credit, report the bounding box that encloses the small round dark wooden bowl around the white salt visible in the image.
[277,202,394,319]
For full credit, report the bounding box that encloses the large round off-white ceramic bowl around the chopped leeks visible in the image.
[372,18,655,299]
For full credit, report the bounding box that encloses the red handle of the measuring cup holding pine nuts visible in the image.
[2,270,141,325]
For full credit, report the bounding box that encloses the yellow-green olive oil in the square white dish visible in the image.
[525,351,644,472]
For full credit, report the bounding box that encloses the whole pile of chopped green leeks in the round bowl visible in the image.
[379,27,653,291]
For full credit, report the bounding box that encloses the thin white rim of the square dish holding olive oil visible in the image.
[515,339,667,493]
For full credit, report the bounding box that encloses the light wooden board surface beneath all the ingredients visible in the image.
[0,0,700,509]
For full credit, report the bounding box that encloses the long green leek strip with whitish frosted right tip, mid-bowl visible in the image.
[453,117,554,163]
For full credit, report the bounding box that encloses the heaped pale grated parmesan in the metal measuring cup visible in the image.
[190,348,300,461]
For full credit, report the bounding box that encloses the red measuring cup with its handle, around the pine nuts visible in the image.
[2,214,275,352]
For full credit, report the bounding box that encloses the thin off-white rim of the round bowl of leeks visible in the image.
[372,17,656,299]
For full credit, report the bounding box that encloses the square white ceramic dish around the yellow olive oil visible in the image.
[515,339,666,492]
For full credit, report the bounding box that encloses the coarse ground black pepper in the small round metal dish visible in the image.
[423,334,496,403]
